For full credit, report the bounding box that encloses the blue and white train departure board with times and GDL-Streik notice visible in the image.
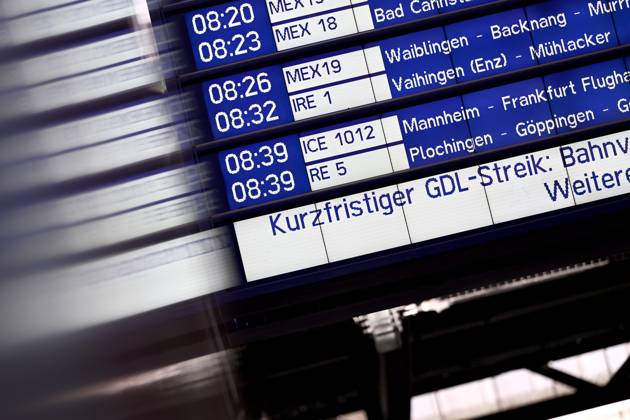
[175,0,630,281]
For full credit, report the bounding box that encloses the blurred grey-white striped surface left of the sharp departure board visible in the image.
[0,0,241,349]
